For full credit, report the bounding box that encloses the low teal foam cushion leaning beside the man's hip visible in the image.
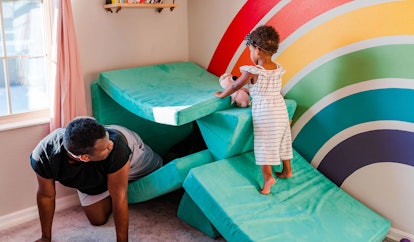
[128,150,213,203]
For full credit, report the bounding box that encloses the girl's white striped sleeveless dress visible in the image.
[240,64,293,165]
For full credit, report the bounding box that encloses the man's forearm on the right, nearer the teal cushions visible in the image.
[108,161,130,242]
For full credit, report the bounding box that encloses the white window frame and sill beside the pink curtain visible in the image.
[0,0,56,131]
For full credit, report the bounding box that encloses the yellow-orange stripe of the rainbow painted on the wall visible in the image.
[275,1,414,84]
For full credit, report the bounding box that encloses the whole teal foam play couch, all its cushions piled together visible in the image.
[91,62,390,242]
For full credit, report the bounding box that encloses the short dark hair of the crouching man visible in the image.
[63,117,106,155]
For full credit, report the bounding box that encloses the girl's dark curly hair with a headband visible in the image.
[250,25,280,54]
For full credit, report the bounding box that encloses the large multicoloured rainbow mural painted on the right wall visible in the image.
[208,0,414,234]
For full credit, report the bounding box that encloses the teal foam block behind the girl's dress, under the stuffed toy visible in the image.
[197,99,296,160]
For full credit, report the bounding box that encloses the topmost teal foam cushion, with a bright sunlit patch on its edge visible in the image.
[98,62,231,125]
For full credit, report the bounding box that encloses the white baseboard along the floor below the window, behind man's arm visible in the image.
[0,194,80,231]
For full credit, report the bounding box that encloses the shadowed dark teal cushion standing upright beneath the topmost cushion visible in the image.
[91,81,193,157]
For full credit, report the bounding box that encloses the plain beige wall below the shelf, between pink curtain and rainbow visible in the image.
[72,0,188,113]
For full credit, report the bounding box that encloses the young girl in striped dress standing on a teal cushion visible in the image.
[214,26,293,194]
